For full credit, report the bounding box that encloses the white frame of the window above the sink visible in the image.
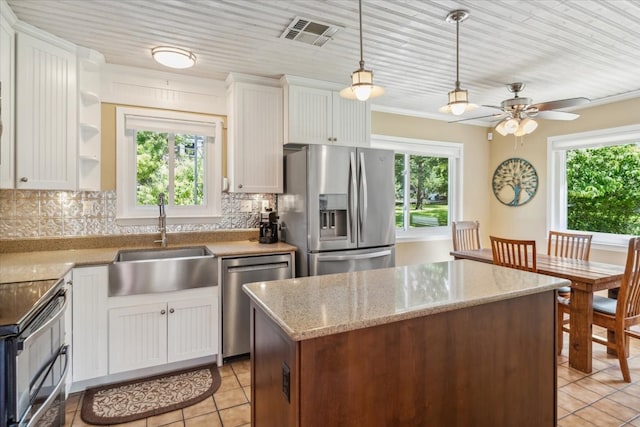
[116,107,223,225]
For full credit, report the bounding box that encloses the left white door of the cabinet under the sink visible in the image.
[109,303,168,374]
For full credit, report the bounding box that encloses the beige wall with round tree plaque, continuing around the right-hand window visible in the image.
[485,98,640,264]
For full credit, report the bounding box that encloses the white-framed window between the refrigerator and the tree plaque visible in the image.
[371,135,462,238]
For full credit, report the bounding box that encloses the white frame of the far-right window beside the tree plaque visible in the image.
[547,124,640,251]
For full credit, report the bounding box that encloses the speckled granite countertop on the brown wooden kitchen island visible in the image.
[243,260,570,341]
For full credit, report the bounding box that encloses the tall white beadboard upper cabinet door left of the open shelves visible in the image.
[16,32,77,190]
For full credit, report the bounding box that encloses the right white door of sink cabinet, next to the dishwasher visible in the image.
[167,293,218,363]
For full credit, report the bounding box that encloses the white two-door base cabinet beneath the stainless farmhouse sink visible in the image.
[109,287,218,374]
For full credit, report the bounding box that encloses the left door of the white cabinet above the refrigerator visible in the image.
[288,86,333,144]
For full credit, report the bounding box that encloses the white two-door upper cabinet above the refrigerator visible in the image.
[281,76,371,147]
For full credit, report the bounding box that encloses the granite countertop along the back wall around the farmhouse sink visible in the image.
[0,240,295,283]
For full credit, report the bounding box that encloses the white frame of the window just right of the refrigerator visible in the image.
[371,135,464,241]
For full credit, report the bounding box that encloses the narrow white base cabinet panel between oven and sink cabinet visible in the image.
[71,265,109,382]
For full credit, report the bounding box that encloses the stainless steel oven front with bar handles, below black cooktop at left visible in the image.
[15,292,69,427]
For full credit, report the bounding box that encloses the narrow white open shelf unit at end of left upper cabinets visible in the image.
[78,48,104,191]
